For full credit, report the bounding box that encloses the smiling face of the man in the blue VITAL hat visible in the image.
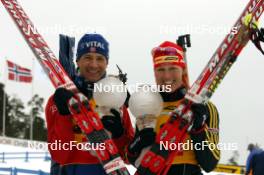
[77,53,107,82]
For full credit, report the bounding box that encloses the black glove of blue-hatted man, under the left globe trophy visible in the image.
[101,108,124,139]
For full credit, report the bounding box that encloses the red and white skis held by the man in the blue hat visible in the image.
[1,0,129,175]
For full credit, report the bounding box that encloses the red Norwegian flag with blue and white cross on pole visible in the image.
[6,60,32,83]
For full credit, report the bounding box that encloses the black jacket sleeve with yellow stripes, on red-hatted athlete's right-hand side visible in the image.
[191,102,220,172]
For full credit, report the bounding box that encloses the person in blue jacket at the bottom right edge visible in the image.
[246,143,264,175]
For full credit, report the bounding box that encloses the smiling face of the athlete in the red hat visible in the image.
[154,65,183,92]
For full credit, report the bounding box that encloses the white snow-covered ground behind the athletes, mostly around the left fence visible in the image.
[0,137,239,175]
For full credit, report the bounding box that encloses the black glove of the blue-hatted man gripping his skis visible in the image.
[53,88,74,115]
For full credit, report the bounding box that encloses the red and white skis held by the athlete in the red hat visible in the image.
[136,0,264,175]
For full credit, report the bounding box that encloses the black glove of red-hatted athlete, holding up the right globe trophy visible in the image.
[128,128,156,154]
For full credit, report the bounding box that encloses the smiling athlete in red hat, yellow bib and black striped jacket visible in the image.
[128,41,220,175]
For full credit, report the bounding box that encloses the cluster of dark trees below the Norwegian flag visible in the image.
[0,86,47,141]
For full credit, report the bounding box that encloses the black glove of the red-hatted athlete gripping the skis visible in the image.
[191,103,208,131]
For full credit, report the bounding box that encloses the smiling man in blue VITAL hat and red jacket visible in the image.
[45,34,134,175]
